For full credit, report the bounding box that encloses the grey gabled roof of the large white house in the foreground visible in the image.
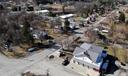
[73,43,103,62]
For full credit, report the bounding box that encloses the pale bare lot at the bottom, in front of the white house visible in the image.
[23,59,82,76]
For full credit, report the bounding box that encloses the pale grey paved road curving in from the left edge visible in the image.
[0,49,56,76]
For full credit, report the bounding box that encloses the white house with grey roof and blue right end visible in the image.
[73,43,107,71]
